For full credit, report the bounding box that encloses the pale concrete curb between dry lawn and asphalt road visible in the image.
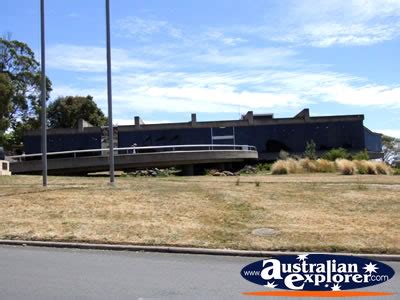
[0,240,400,261]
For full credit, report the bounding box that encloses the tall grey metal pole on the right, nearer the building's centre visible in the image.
[106,0,115,184]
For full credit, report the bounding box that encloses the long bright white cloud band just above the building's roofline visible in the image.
[52,69,400,120]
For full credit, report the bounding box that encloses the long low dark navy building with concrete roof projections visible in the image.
[24,109,382,160]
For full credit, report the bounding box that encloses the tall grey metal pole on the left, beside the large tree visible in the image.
[40,0,47,187]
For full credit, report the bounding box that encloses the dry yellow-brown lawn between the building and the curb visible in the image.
[0,173,400,253]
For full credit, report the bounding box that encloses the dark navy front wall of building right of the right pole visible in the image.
[118,121,365,157]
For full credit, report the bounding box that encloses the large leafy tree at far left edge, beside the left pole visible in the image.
[0,38,51,150]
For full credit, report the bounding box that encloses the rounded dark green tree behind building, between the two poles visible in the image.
[47,96,107,128]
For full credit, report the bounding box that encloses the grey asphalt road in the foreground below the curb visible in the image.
[0,246,400,299]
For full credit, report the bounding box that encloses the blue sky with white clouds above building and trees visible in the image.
[0,0,400,138]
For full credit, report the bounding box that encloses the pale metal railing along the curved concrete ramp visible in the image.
[8,144,257,161]
